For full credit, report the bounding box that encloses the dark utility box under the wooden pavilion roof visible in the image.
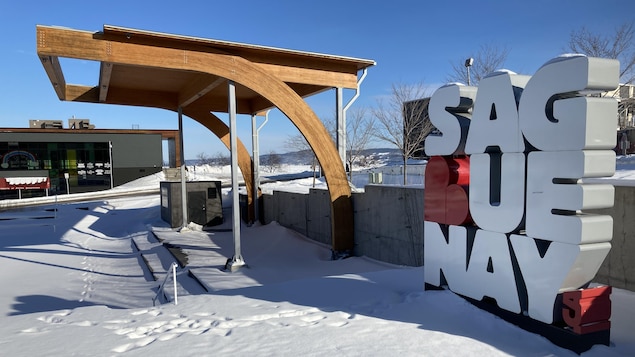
[160,181,223,228]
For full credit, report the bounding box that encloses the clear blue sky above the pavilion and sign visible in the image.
[0,0,635,159]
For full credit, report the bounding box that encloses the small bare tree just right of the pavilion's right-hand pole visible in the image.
[346,108,375,181]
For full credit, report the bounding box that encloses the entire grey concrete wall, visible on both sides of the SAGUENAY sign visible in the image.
[263,185,635,291]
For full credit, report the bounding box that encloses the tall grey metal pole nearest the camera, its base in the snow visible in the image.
[225,81,245,272]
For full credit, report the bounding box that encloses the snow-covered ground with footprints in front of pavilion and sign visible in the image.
[0,158,635,356]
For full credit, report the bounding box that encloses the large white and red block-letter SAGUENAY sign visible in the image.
[424,55,619,350]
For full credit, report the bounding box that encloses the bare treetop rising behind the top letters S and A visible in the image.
[447,44,509,85]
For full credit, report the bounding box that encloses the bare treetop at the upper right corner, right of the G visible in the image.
[567,23,635,83]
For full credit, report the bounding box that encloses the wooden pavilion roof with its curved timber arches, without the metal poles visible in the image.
[37,25,375,251]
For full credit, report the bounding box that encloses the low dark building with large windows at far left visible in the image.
[0,118,180,198]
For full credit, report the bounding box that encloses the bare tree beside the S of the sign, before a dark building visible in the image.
[372,83,434,185]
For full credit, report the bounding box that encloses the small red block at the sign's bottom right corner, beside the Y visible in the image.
[562,286,612,334]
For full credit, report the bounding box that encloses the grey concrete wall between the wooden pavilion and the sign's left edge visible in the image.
[263,185,423,266]
